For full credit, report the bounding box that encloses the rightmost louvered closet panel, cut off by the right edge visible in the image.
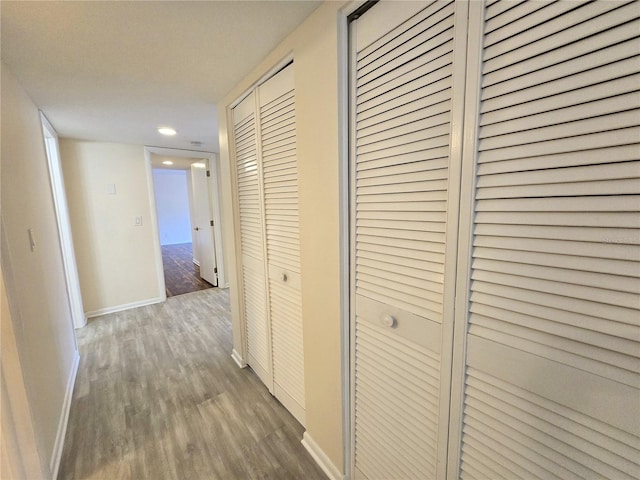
[461,1,640,480]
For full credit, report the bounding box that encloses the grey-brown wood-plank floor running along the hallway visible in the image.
[58,288,326,480]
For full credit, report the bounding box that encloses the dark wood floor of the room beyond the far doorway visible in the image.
[162,243,213,297]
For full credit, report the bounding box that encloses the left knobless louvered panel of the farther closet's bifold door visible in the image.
[233,93,272,389]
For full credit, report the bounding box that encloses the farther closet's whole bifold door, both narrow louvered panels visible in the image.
[233,65,305,424]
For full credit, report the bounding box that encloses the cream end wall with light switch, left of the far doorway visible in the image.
[60,138,164,316]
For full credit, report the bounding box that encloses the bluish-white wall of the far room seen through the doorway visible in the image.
[153,168,191,245]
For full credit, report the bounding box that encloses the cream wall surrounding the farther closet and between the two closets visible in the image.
[218,2,345,471]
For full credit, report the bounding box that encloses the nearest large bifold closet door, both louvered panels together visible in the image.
[350,0,640,480]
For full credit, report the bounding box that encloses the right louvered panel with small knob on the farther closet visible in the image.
[258,65,305,425]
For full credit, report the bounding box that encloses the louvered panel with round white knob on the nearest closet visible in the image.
[351,1,464,480]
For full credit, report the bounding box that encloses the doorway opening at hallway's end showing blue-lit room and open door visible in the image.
[150,152,218,297]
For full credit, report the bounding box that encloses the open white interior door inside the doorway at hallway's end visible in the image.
[191,160,218,286]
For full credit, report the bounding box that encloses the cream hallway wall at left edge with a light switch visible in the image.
[0,65,78,478]
